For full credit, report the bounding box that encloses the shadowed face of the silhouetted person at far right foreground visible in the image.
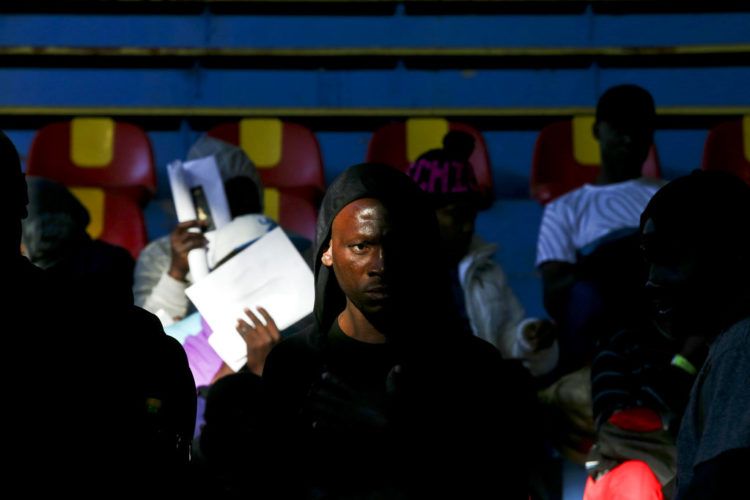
[641,219,710,339]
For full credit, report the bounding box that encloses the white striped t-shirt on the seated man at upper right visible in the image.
[536,177,665,266]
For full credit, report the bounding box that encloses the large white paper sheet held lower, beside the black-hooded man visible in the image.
[185,228,315,371]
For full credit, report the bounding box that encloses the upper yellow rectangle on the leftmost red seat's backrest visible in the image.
[70,118,115,168]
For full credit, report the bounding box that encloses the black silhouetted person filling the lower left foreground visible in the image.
[0,130,195,494]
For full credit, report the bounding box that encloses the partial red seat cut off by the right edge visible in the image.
[701,116,750,184]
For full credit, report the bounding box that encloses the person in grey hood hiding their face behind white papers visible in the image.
[133,136,310,387]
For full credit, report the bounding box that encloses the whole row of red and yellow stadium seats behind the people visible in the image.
[26,116,750,256]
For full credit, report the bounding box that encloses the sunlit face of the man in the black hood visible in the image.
[321,198,403,317]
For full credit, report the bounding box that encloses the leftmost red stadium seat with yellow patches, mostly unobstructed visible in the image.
[26,118,156,257]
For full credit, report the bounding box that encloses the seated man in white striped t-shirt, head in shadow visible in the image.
[536,85,662,373]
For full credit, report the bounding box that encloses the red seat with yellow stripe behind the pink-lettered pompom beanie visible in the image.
[367,118,494,204]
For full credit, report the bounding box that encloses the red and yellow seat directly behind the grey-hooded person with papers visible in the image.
[208,119,325,239]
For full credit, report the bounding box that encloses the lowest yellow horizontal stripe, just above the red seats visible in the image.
[0,106,750,119]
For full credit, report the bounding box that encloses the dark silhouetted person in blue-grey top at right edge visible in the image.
[640,171,750,500]
